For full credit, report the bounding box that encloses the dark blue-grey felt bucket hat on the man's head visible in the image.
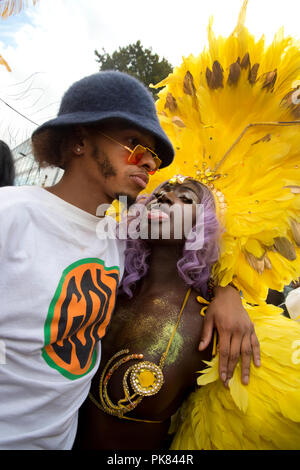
[32,71,174,168]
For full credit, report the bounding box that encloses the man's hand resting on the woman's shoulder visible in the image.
[199,286,260,386]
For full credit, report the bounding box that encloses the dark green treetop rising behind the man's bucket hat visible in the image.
[95,41,173,97]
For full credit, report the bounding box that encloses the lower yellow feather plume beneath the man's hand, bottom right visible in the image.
[171,302,300,450]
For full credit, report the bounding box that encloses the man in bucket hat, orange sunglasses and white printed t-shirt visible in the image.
[0,72,174,449]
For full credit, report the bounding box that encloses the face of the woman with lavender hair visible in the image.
[141,181,201,244]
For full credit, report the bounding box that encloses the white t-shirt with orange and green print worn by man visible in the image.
[0,186,124,449]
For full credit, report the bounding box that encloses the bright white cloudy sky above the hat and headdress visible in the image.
[0,0,300,148]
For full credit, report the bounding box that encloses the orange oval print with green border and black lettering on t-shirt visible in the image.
[42,258,119,380]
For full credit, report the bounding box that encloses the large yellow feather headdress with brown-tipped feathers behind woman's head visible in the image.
[147,1,300,303]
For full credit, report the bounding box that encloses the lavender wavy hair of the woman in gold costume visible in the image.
[120,178,219,297]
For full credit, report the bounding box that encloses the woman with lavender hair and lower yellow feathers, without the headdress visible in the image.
[77,178,300,450]
